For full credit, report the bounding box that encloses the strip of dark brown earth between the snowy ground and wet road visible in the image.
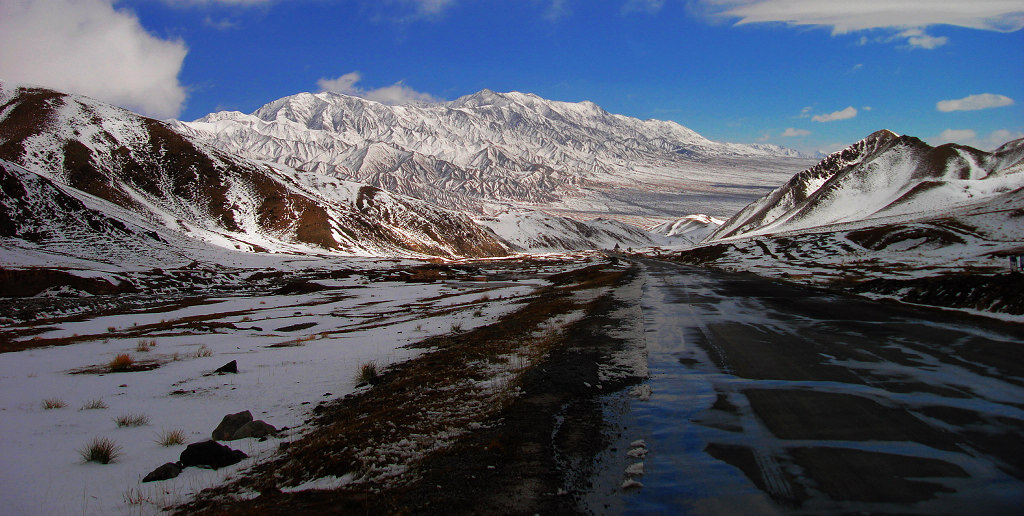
[177,267,638,514]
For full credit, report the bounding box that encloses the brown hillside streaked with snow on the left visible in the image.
[0,82,509,257]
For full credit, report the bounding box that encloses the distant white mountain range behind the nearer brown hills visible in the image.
[172,90,808,222]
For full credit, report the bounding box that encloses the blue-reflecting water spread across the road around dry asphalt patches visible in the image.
[584,264,1024,514]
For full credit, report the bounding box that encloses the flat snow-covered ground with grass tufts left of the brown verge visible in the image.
[0,251,593,514]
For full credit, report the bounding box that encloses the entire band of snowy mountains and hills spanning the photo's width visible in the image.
[6,82,1024,270]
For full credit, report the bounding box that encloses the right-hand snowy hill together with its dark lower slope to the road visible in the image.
[674,131,1024,319]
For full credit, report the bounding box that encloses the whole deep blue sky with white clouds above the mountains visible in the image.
[0,0,1024,151]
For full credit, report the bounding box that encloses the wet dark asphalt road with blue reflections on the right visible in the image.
[621,260,1024,514]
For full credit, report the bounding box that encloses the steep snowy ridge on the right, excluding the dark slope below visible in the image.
[709,130,1024,241]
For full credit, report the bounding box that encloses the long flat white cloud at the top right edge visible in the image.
[699,0,1024,49]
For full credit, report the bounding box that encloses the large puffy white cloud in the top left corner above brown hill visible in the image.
[0,0,188,118]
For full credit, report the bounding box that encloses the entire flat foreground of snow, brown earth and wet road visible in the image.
[0,256,1024,514]
